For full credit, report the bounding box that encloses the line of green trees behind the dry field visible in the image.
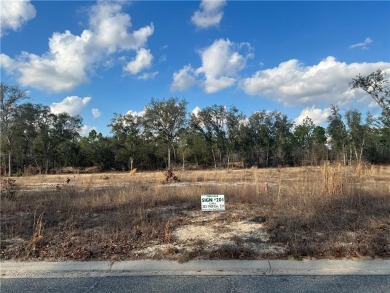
[0,70,390,176]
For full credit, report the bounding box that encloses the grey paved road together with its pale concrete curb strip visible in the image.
[0,260,390,293]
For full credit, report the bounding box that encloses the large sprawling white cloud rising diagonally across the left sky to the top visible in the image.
[0,2,154,92]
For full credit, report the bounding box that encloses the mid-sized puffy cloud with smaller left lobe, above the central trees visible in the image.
[171,39,253,93]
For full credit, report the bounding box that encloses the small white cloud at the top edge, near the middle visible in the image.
[191,0,226,29]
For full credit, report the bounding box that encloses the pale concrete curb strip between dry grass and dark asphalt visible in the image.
[0,260,390,278]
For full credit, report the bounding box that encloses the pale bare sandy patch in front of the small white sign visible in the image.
[136,211,285,257]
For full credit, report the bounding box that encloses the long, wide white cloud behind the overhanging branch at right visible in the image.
[240,56,390,106]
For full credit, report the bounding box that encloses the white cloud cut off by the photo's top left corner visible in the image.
[0,0,36,36]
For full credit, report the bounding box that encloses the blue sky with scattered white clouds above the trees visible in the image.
[0,0,390,135]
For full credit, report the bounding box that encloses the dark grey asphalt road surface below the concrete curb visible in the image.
[0,275,390,293]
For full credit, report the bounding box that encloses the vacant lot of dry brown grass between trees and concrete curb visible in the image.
[0,165,390,261]
